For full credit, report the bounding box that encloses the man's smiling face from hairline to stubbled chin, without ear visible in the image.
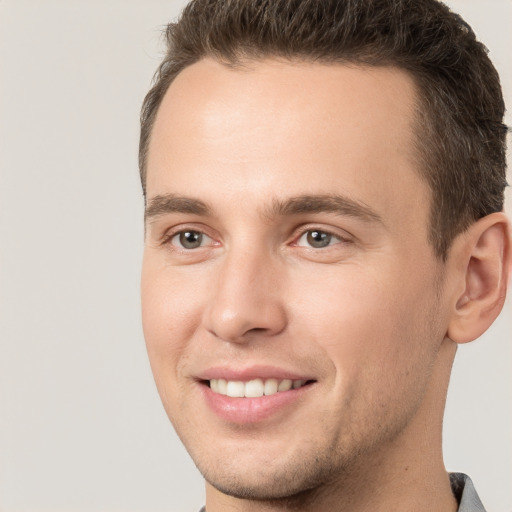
[142,60,452,498]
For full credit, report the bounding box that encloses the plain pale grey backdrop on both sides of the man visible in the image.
[0,0,512,512]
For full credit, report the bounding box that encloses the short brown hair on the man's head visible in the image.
[139,0,507,259]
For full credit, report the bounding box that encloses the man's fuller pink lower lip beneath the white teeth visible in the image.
[201,383,313,424]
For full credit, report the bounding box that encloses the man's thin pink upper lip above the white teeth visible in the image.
[197,365,314,382]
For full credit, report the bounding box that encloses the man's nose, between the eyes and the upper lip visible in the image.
[204,251,287,343]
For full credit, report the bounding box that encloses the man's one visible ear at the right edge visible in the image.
[447,212,512,343]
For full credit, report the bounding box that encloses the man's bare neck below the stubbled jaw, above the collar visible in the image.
[206,339,458,512]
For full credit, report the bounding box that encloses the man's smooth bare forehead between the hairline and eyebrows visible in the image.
[147,60,428,234]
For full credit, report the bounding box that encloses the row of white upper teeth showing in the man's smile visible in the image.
[210,379,306,398]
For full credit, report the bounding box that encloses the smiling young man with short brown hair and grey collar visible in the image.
[140,0,511,512]
